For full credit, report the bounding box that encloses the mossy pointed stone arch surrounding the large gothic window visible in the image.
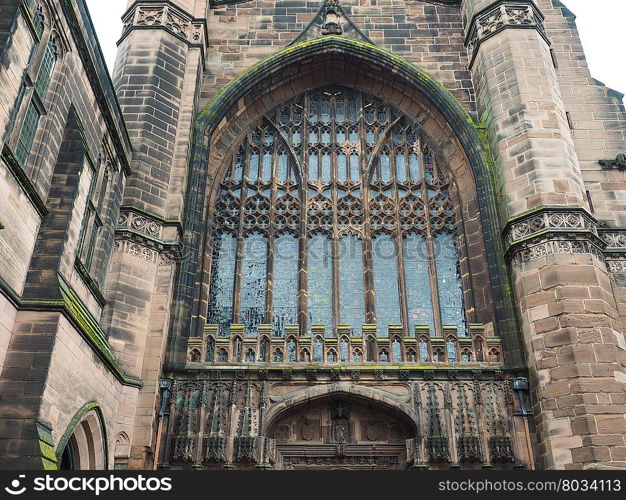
[173,36,520,366]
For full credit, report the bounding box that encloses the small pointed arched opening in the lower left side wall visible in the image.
[59,407,107,470]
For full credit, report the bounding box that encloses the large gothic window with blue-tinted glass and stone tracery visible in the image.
[208,87,468,342]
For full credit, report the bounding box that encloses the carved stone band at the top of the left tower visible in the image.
[122,2,208,49]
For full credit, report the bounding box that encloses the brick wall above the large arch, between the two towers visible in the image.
[203,0,474,110]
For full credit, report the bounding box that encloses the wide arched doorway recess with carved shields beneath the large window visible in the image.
[268,394,415,470]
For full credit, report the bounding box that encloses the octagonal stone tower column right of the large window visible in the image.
[462,0,626,469]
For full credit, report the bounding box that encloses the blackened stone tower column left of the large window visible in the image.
[105,0,207,468]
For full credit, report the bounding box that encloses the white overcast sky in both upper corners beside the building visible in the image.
[87,0,626,94]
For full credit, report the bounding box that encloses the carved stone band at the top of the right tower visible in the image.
[465,0,550,67]
